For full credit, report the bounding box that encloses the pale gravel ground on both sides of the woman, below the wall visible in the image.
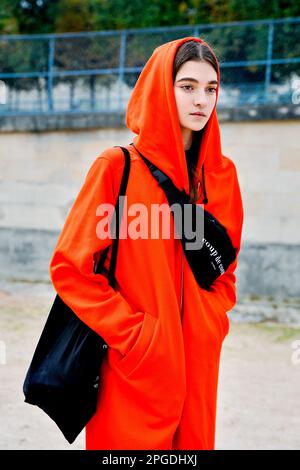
[0,282,300,449]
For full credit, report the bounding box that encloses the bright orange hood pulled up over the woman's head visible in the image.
[126,36,222,194]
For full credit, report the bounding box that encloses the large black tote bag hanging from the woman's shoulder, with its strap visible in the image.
[23,148,130,444]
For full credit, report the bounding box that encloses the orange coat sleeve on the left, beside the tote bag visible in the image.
[49,156,145,354]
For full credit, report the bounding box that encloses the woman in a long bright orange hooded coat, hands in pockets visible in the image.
[50,37,243,450]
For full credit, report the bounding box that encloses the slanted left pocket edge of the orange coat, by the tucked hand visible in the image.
[116,312,158,377]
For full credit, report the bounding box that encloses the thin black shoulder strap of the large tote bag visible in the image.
[94,145,130,287]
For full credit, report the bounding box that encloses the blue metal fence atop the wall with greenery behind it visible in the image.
[0,18,300,115]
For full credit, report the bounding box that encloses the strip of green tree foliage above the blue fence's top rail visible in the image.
[0,0,300,34]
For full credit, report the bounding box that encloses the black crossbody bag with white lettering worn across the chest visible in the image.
[136,149,237,290]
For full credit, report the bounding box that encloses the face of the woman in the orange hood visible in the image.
[174,60,218,148]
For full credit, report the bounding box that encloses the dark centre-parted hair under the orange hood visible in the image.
[173,40,218,202]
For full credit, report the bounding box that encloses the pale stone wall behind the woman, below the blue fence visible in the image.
[0,121,300,297]
